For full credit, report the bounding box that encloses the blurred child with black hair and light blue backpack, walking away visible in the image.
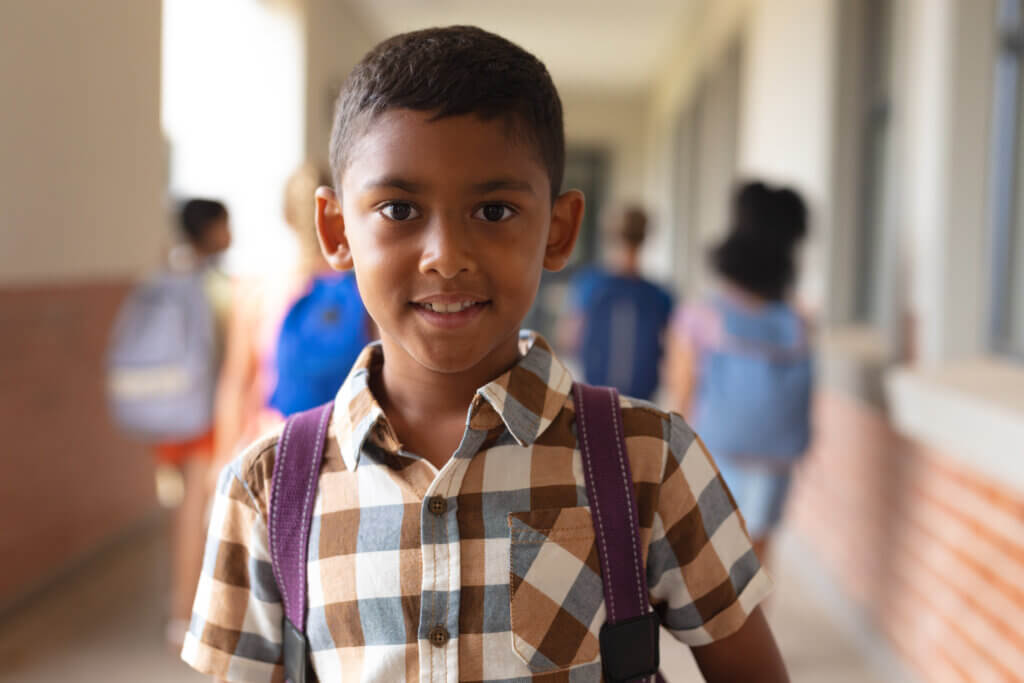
[667,182,812,560]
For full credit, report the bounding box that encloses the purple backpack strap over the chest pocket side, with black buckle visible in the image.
[572,382,664,682]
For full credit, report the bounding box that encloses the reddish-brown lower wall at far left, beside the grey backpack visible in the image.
[0,283,155,606]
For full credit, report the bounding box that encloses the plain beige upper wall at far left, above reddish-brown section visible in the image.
[0,0,166,284]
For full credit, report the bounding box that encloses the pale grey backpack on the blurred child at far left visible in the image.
[106,270,217,441]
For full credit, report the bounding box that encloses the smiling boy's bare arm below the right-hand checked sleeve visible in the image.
[690,607,790,683]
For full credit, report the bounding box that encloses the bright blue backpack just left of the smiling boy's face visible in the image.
[268,273,370,416]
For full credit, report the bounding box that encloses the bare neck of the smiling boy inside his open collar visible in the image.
[371,335,519,464]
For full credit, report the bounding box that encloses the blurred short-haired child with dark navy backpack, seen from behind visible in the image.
[559,206,672,400]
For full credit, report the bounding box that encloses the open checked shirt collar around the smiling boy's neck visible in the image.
[334,331,572,471]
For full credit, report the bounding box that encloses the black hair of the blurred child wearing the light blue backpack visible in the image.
[711,181,807,301]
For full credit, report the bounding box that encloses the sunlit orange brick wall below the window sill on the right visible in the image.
[788,391,1024,681]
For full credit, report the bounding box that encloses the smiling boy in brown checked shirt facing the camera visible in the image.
[182,27,785,681]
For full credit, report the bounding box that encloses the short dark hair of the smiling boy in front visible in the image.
[331,26,565,199]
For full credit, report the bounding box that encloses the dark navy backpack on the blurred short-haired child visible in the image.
[580,278,672,400]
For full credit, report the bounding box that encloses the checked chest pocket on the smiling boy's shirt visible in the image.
[508,508,604,673]
